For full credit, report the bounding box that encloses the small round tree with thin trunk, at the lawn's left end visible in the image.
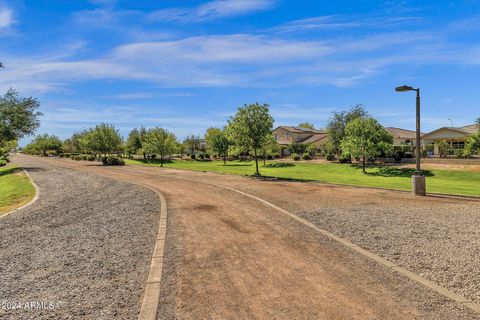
[144,127,177,167]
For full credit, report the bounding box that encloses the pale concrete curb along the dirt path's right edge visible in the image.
[210,184,480,314]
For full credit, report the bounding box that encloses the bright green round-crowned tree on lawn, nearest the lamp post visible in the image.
[341,118,393,173]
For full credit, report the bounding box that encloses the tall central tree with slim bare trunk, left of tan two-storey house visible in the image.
[228,103,273,175]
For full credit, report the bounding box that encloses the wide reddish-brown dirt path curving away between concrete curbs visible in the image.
[32,159,477,319]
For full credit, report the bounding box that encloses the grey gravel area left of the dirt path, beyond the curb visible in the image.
[0,157,160,319]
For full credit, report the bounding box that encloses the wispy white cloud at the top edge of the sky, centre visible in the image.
[149,0,275,22]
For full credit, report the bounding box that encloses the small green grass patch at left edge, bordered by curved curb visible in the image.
[0,165,35,215]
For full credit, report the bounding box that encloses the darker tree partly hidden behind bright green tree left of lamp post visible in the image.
[327,104,369,156]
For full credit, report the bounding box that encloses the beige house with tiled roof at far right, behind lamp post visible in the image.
[422,124,480,154]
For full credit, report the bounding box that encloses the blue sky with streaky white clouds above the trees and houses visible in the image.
[0,0,480,142]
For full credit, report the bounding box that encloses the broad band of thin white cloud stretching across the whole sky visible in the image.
[0,25,480,94]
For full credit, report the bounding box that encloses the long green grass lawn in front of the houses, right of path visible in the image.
[126,160,480,196]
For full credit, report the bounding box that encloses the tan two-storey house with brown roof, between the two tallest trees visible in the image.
[272,126,327,157]
